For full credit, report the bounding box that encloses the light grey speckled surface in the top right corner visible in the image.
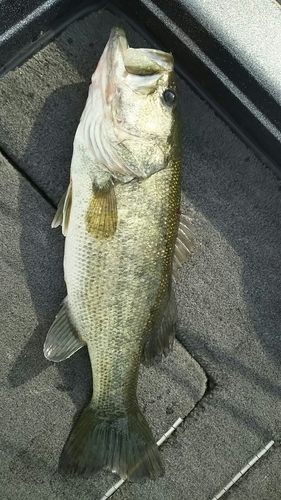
[183,0,281,104]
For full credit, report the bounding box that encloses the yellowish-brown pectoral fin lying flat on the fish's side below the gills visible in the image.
[86,180,117,239]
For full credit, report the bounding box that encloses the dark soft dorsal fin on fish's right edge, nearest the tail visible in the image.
[143,289,177,366]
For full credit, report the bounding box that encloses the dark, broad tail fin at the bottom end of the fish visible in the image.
[60,404,164,481]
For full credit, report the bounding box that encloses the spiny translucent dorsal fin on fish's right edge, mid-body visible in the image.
[172,214,194,279]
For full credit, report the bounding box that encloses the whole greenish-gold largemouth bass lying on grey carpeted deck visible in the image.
[44,28,193,482]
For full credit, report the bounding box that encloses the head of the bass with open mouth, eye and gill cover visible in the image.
[77,28,178,182]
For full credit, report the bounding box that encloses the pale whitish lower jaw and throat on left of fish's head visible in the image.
[74,28,133,182]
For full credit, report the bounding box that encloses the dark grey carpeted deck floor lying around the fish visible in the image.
[0,10,281,500]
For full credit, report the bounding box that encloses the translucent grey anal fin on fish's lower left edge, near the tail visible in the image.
[44,299,85,363]
